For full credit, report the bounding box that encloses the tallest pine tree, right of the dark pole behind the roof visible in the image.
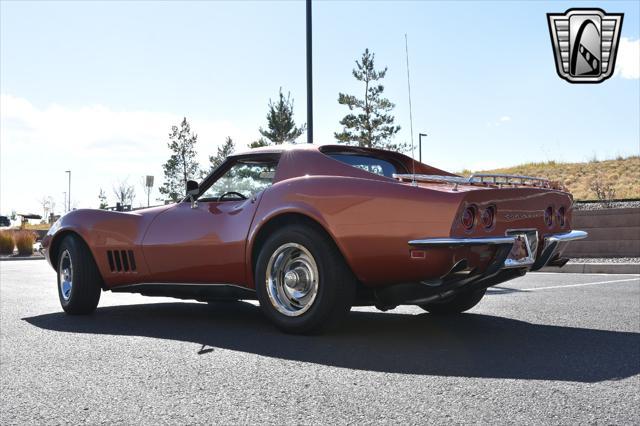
[334,49,407,151]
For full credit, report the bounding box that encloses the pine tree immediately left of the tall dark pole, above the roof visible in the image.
[258,87,307,147]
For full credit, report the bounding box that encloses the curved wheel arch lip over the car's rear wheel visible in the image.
[247,211,355,287]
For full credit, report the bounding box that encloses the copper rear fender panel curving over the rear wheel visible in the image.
[246,176,462,285]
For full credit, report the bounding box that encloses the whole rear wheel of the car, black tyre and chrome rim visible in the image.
[255,225,356,334]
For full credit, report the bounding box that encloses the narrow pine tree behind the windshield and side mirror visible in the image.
[159,117,199,202]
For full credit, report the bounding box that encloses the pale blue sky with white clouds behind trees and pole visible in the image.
[0,0,640,212]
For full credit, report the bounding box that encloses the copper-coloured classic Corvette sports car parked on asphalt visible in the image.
[43,145,586,333]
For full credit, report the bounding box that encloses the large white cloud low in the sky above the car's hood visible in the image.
[0,94,253,213]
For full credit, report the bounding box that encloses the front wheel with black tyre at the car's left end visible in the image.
[57,235,102,314]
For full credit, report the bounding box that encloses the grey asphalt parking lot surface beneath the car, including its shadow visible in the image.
[0,260,640,424]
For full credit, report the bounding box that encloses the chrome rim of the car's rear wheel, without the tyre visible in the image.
[266,243,320,317]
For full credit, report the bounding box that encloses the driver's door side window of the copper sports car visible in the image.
[199,161,277,201]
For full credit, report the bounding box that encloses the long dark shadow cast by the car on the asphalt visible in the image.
[23,302,640,382]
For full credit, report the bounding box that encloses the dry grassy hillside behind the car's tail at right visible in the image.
[461,156,640,200]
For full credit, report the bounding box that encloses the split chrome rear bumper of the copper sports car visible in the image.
[409,230,588,271]
